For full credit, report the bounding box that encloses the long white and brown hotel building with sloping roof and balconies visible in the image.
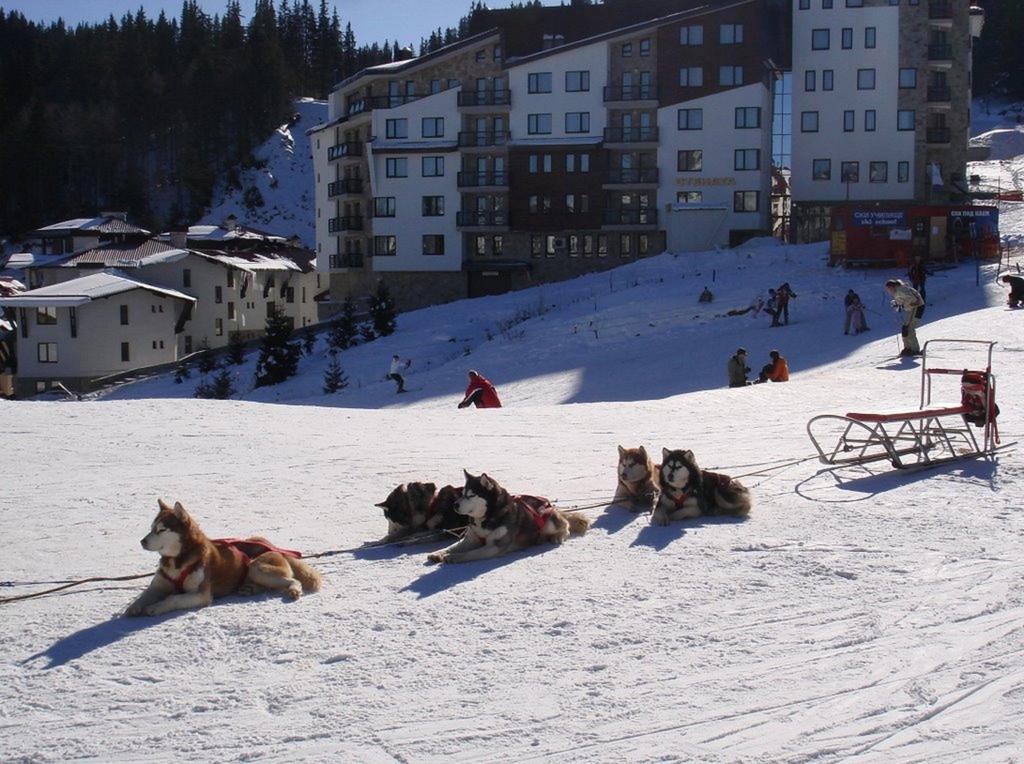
[311,0,777,309]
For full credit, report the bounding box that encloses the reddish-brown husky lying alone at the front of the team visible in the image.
[125,499,321,616]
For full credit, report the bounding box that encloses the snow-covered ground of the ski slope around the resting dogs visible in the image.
[0,236,1024,762]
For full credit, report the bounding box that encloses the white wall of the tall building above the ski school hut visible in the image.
[792,0,913,202]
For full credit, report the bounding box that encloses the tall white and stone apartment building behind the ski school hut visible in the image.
[792,0,983,241]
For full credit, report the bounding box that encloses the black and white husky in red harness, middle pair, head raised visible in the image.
[427,470,590,562]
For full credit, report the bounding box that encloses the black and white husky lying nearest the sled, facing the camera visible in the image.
[650,449,751,525]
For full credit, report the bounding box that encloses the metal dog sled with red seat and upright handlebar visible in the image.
[807,339,1005,469]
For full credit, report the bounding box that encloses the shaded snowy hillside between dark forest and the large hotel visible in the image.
[199,98,327,247]
